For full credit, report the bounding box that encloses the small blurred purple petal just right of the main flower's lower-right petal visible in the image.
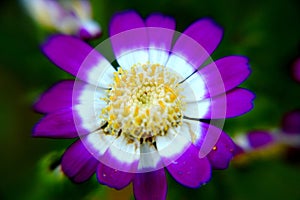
[247,131,275,149]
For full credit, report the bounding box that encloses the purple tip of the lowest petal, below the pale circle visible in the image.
[133,169,167,200]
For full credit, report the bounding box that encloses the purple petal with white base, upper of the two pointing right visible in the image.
[182,56,250,101]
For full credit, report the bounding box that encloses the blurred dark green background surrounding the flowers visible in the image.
[0,0,300,200]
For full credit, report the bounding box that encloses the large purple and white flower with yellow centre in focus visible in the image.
[33,11,254,199]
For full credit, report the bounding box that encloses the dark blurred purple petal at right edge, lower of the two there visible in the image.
[281,110,300,134]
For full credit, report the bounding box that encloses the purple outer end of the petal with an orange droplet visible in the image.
[207,132,235,169]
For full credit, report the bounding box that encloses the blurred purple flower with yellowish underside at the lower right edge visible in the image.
[234,110,300,163]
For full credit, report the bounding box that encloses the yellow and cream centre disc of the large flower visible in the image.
[100,63,183,142]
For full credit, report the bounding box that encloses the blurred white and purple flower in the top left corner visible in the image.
[22,0,101,39]
